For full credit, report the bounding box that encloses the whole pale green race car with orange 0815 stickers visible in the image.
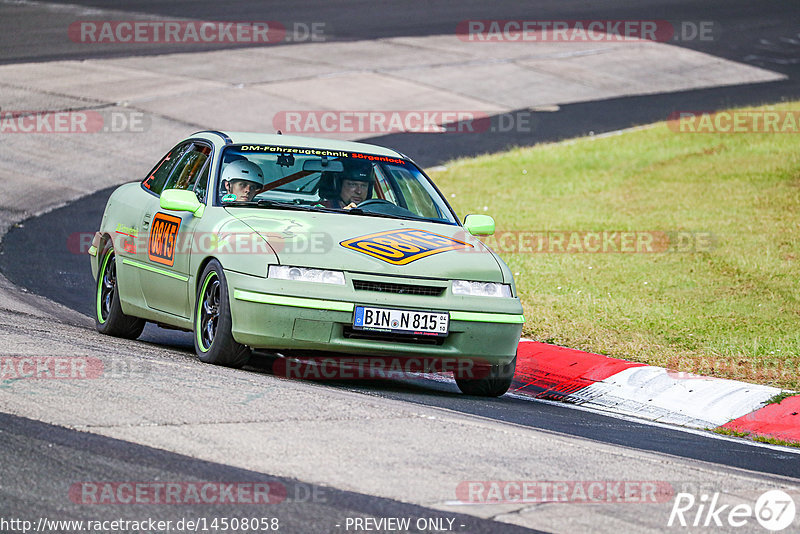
[89,131,524,396]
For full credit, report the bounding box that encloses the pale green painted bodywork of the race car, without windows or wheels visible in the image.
[92,132,524,364]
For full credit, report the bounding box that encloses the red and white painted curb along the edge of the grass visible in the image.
[512,339,800,441]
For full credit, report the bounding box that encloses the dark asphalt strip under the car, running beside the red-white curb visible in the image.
[0,189,800,478]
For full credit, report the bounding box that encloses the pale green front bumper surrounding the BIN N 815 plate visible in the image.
[225,272,523,364]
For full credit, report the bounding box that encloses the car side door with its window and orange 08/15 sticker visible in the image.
[139,141,212,318]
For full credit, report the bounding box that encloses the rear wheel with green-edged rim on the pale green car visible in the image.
[94,241,146,339]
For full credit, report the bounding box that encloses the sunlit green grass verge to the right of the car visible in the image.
[432,102,800,389]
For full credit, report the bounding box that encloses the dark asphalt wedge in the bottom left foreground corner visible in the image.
[0,414,535,534]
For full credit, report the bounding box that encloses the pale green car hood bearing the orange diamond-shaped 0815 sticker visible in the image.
[226,208,503,282]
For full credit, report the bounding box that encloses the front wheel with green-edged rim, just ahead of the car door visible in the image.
[193,260,251,368]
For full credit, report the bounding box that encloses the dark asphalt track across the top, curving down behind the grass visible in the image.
[0,0,800,166]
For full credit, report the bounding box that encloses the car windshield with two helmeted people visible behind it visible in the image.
[216,145,457,224]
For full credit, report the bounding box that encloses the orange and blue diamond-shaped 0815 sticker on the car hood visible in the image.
[339,228,473,265]
